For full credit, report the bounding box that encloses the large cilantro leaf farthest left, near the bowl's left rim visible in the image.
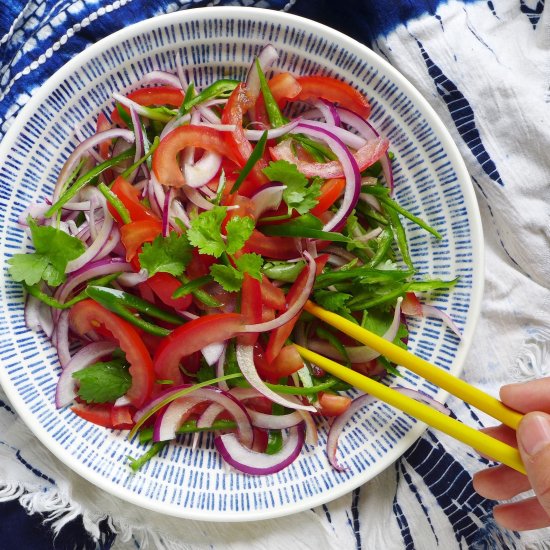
[8,218,86,286]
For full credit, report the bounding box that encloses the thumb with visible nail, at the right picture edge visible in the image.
[517,412,550,516]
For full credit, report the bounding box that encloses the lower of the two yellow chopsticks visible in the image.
[294,344,526,474]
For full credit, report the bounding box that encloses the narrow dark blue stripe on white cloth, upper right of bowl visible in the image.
[416,39,504,186]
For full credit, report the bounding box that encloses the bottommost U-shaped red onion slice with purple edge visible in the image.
[214,424,304,475]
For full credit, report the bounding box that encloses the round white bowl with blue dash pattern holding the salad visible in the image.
[0,7,483,521]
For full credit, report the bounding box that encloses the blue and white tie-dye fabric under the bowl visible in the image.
[0,0,550,550]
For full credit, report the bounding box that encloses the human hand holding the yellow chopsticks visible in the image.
[473,378,550,531]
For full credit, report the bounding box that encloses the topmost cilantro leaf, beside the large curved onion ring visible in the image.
[263,160,321,214]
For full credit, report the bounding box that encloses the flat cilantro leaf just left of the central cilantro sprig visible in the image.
[139,231,192,277]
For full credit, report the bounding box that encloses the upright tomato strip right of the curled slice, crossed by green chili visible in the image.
[222,83,268,197]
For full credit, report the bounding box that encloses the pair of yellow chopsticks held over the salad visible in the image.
[296,301,526,474]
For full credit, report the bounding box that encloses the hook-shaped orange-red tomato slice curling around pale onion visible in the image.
[152,124,246,187]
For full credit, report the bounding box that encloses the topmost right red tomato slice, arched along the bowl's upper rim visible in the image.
[289,76,371,118]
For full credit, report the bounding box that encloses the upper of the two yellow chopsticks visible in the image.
[304,301,523,430]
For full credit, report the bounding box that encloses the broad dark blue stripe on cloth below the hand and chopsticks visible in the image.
[402,431,519,550]
